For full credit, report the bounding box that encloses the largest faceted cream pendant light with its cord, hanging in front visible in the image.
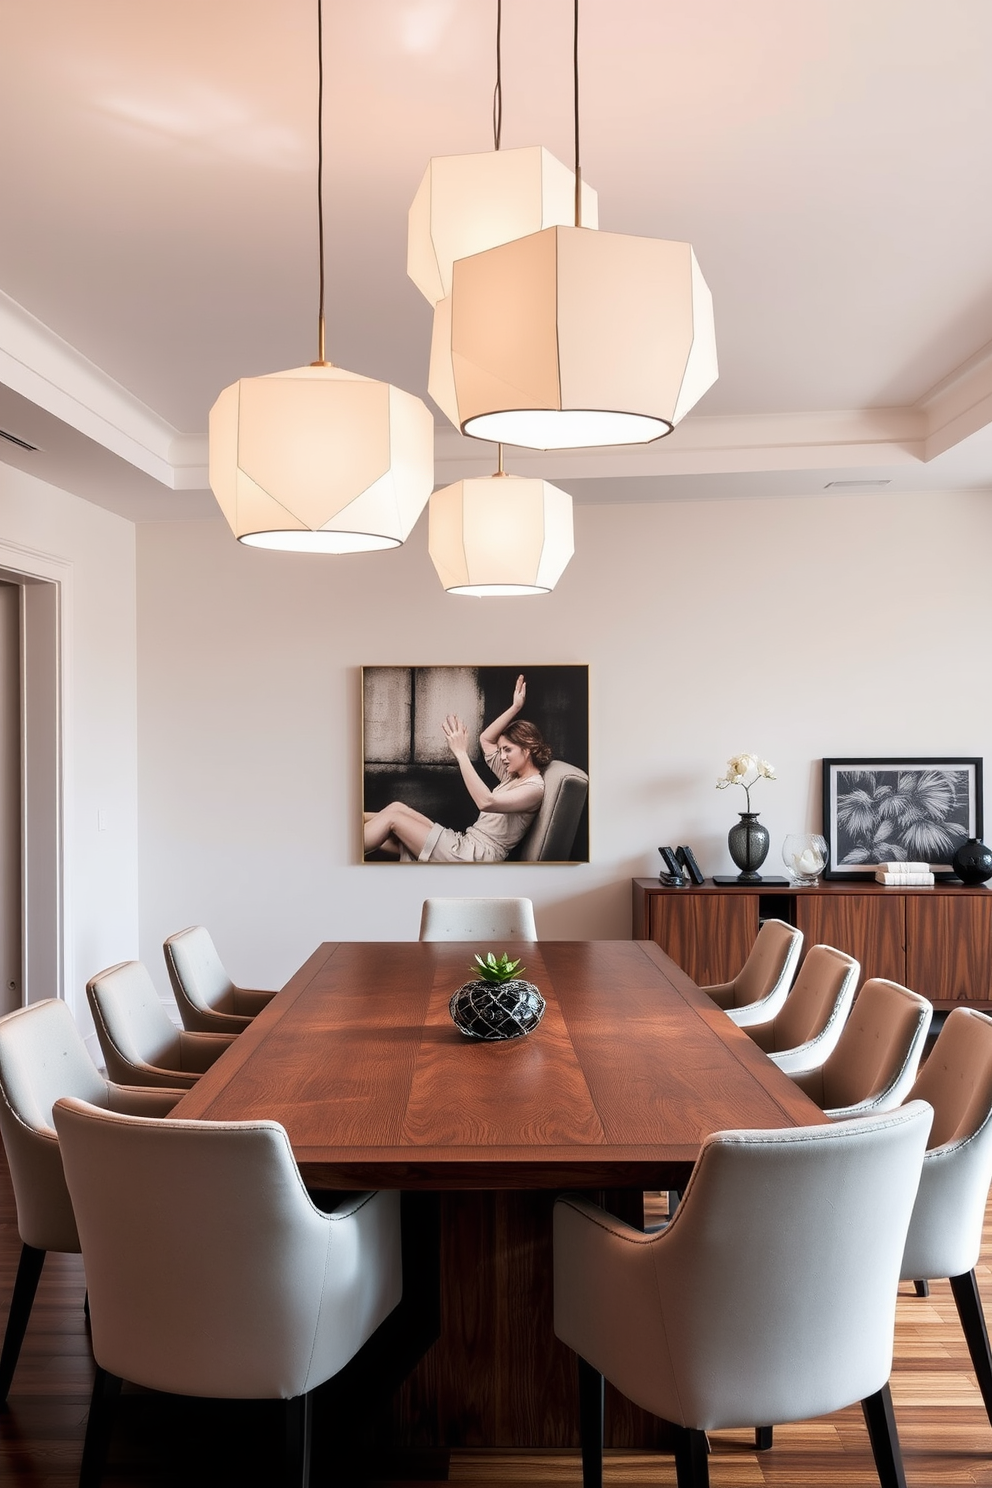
[431,0,717,449]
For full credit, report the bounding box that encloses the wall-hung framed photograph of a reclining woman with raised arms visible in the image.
[361,665,589,865]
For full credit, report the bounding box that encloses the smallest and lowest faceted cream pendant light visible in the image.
[427,445,574,598]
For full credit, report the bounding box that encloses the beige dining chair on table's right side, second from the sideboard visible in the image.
[745,945,861,1074]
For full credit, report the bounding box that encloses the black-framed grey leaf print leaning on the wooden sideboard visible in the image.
[822,756,983,881]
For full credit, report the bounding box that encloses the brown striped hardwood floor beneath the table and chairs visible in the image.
[0,1159,992,1488]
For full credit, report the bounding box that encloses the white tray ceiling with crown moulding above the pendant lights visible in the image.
[0,0,992,519]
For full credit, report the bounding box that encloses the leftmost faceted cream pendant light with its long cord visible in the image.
[210,0,434,554]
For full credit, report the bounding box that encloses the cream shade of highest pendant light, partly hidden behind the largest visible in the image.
[406,144,599,305]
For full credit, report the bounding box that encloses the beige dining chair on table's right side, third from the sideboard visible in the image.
[785,976,934,1119]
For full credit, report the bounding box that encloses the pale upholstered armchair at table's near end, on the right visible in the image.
[555,1101,933,1488]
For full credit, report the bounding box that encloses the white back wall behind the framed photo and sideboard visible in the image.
[133,494,992,987]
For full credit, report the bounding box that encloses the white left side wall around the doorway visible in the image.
[0,464,138,1030]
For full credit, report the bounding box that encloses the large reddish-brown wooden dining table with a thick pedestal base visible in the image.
[174,940,824,1452]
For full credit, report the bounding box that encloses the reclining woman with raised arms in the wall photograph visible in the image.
[364,674,552,863]
